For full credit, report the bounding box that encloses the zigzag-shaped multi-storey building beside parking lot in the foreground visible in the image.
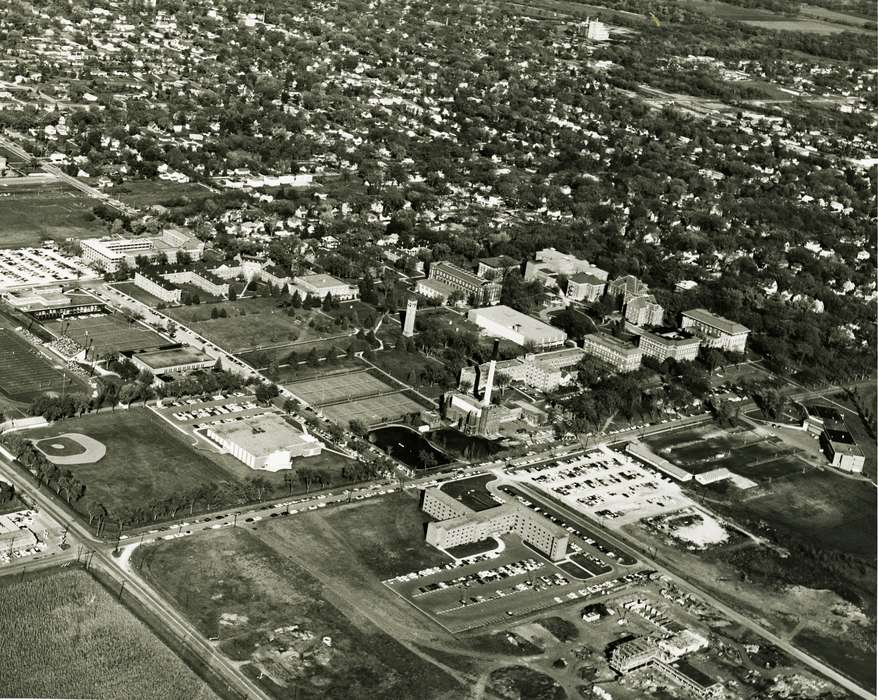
[421,488,569,561]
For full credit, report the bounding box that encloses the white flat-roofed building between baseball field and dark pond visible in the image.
[204,413,323,472]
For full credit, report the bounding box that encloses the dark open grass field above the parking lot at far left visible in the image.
[0,180,106,248]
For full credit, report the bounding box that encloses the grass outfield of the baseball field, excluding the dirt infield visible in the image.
[27,408,237,520]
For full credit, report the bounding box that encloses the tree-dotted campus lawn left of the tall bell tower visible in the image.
[165,297,336,352]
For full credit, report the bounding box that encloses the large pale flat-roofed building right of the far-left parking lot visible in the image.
[80,229,204,272]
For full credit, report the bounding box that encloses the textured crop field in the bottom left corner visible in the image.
[0,569,217,700]
